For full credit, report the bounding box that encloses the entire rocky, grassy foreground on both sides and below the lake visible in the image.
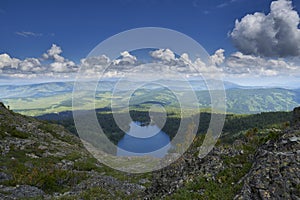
[0,104,300,200]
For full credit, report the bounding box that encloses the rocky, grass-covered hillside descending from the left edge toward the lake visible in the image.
[0,103,147,199]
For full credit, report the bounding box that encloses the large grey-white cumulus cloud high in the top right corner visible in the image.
[230,0,300,57]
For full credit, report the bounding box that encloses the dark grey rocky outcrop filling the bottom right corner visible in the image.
[235,108,300,200]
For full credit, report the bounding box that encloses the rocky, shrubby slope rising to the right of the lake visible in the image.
[146,108,300,200]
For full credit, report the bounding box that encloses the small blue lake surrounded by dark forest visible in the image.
[117,122,171,158]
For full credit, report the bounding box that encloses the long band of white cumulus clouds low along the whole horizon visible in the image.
[0,44,300,78]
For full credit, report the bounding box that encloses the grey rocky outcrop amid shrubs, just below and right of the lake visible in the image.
[145,140,246,199]
